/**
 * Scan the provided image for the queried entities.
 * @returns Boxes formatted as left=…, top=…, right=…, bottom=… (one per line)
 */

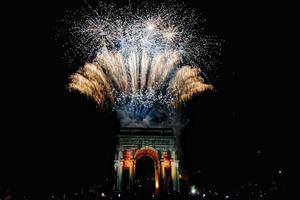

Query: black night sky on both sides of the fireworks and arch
left=0, top=0, right=300, bottom=199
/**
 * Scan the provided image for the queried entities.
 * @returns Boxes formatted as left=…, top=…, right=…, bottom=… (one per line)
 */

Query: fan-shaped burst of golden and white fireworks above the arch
left=64, top=0, right=218, bottom=127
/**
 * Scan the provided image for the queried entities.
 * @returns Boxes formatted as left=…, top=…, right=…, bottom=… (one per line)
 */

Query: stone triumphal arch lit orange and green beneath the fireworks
left=113, top=128, right=180, bottom=194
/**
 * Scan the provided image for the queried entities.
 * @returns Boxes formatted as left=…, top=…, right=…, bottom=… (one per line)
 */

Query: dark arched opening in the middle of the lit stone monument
left=135, top=155, right=155, bottom=196
